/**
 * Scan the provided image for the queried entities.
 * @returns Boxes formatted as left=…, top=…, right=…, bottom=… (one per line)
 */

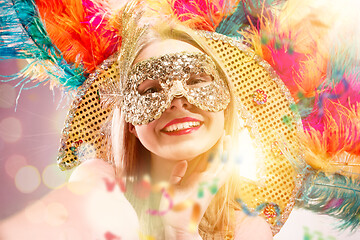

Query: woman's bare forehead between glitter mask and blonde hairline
left=134, top=39, right=202, bottom=64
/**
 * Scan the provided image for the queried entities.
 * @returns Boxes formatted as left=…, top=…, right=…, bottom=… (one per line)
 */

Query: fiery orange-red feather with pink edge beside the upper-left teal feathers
left=36, top=0, right=121, bottom=73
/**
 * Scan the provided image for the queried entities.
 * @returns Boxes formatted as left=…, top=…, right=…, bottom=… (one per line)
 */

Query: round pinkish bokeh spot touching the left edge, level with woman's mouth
left=0, top=117, right=22, bottom=143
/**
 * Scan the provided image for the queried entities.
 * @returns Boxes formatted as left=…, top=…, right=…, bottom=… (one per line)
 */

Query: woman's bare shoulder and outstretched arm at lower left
left=0, top=159, right=139, bottom=240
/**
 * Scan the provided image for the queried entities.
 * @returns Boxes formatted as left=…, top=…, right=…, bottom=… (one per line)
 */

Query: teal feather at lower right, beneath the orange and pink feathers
left=296, top=171, right=360, bottom=230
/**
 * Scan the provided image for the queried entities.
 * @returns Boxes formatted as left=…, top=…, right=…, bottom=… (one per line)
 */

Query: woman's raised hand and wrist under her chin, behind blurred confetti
left=160, top=151, right=229, bottom=240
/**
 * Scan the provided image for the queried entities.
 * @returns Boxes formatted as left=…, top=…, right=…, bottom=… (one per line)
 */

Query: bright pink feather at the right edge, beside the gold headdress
left=303, top=74, right=360, bottom=155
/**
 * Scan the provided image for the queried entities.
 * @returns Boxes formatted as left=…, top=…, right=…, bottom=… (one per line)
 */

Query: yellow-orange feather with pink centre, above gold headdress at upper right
left=241, top=1, right=334, bottom=103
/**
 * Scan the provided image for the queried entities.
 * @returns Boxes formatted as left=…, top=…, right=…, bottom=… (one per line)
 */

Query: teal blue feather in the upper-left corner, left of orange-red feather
left=0, top=0, right=86, bottom=89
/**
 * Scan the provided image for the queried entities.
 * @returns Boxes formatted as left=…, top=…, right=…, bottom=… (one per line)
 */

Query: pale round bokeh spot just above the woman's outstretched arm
left=42, top=164, right=67, bottom=189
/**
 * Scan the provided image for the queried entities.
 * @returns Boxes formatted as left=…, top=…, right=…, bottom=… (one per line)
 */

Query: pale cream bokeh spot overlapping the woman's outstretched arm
left=45, top=202, right=69, bottom=227
